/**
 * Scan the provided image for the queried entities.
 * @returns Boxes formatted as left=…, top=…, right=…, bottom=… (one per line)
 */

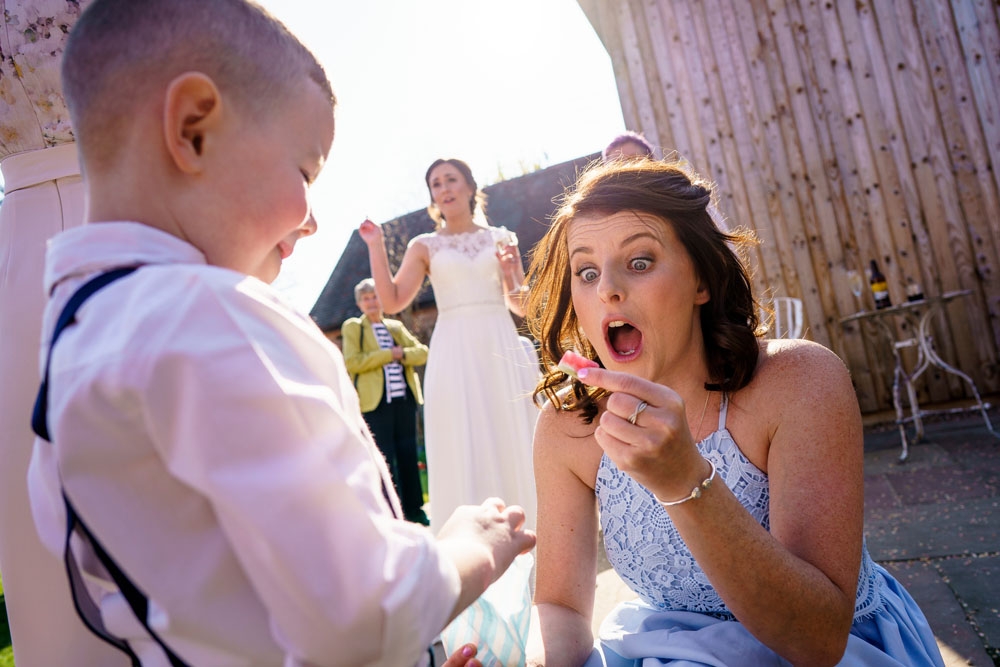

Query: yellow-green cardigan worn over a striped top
left=340, top=315, right=427, bottom=412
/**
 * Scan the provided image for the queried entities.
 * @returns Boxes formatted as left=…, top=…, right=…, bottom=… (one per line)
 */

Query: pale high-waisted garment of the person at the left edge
left=0, top=144, right=128, bottom=667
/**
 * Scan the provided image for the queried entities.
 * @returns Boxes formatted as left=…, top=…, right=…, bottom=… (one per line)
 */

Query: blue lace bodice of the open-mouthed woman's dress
left=595, top=400, right=882, bottom=620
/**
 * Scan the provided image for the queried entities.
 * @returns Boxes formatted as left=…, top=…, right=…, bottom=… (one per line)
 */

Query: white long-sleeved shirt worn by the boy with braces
left=29, top=223, right=460, bottom=666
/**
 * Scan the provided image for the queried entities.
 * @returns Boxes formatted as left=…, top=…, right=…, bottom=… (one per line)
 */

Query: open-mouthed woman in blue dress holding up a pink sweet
left=528, top=160, right=943, bottom=667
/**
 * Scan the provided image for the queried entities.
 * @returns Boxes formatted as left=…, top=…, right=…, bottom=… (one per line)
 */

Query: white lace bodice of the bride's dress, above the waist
left=410, top=227, right=510, bottom=314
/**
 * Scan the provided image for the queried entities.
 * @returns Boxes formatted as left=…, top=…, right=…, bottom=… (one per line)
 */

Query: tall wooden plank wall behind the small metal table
left=578, top=0, right=1000, bottom=412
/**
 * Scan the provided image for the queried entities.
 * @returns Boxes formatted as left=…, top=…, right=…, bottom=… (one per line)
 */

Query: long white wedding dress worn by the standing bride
left=411, top=227, right=539, bottom=532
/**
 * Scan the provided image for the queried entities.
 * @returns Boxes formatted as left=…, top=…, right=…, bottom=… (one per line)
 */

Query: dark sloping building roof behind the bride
left=309, top=153, right=600, bottom=332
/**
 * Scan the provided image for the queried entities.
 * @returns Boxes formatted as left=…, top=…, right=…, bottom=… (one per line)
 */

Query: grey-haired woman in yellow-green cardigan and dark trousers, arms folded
left=340, top=278, right=428, bottom=526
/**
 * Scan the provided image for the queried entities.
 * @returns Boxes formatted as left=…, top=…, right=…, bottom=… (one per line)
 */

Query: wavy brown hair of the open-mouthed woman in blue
left=526, top=160, right=763, bottom=422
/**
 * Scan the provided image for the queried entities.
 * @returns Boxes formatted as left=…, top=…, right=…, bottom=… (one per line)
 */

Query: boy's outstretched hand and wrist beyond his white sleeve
left=438, top=498, right=535, bottom=621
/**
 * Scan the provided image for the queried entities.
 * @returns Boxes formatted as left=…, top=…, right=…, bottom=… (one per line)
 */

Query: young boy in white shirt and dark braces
left=29, top=0, right=534, bottom=665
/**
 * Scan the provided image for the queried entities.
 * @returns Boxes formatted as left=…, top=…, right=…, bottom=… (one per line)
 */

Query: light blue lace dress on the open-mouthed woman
left=586, top=399, right=944, bottom=667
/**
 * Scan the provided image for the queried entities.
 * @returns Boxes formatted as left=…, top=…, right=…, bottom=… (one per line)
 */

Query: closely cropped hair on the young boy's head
left=62, top=0, right=335, bottom=170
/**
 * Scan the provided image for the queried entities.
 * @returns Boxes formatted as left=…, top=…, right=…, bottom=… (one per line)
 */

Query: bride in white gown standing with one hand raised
left=358, top=158, right=539, bottom=532
